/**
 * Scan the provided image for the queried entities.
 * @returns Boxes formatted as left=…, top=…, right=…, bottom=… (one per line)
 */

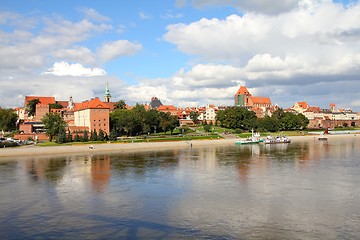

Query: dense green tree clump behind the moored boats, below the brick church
left=216, top=107, right=309, bottom=132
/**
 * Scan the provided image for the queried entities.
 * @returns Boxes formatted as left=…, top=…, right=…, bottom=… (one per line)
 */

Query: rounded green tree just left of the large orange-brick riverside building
left=41, top=112, right=66, bottom=141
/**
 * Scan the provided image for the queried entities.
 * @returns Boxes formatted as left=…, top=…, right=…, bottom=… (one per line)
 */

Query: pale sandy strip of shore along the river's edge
left=0, top=134, right=357, bottom=161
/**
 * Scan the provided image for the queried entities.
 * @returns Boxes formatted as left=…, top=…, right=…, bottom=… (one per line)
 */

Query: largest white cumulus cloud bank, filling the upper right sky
left=164, top=1, right=360, bottom=80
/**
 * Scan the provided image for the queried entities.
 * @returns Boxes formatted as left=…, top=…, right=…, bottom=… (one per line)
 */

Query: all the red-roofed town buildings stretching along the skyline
left=12, top=84, right=360, bottom=140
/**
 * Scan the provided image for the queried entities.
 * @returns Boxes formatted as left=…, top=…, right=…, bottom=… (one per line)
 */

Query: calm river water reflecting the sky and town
left=0, top=136, right=360, bottom=239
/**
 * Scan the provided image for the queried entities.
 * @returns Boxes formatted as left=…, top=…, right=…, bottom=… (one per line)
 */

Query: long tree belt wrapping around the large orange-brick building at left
left=42, top=104, right=179, bottom=143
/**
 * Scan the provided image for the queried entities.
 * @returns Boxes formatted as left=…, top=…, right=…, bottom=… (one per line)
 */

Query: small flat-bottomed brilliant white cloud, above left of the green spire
left=43, top=62, right=106, bottom=77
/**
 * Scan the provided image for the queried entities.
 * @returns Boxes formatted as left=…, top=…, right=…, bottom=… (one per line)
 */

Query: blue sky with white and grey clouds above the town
left=0, top=0, right=360, bottom=111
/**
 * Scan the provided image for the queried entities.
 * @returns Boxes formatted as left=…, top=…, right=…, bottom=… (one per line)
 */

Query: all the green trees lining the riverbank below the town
left=0, top=99, right=309, bottom=143
